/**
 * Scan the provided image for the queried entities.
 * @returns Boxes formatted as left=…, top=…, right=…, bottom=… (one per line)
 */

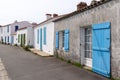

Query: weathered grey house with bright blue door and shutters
left=54, top=0, right=120, bottom=78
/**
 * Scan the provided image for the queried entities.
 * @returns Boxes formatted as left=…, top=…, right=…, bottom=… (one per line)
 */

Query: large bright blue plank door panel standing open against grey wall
left=92, top=22, right=110, bottom=77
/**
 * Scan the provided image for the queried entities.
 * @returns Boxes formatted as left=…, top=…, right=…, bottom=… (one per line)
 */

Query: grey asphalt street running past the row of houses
left=0, top=44, right=108, bottom=80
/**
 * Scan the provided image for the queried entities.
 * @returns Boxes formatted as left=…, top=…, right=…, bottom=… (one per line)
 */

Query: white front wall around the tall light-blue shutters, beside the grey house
left=34, top=22, right=54, bottom=55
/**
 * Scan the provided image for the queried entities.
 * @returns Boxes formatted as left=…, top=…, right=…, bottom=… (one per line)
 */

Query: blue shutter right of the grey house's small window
left=64, top=30, right=69, bottom=52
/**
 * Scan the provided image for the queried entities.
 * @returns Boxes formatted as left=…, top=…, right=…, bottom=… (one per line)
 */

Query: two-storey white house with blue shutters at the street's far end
left=0, top=21, right=32, bottom=45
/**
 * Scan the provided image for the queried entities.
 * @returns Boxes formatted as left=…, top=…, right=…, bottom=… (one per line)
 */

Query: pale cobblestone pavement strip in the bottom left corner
left=0, top=58, right=10, bottom=80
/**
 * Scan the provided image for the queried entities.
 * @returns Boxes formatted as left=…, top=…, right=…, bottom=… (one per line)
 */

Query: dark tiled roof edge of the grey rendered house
left=54, top=0, right=113, bottom=22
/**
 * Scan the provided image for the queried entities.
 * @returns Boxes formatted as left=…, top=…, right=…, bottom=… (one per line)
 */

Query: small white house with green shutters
left=17, top=27, right=34, bottom=46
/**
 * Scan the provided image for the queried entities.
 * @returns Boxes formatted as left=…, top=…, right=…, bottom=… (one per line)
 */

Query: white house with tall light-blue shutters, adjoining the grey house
left=34, top=14, right=61, bottom=55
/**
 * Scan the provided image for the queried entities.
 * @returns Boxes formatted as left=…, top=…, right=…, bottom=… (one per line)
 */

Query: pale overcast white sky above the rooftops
left=0, top=0, right=97, bottom=25
